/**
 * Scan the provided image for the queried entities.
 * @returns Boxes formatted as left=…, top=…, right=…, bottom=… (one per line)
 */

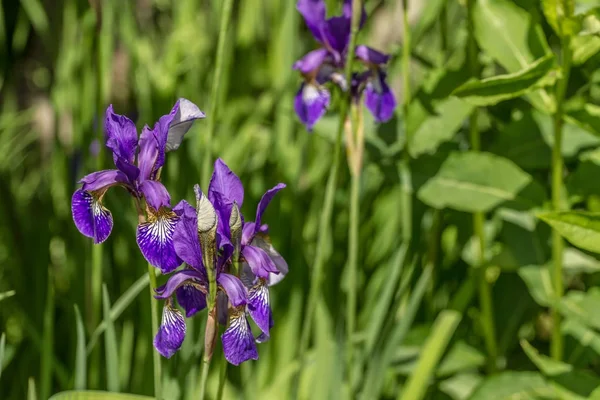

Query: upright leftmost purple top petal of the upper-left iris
left=104, top=104, right=138, bottom=165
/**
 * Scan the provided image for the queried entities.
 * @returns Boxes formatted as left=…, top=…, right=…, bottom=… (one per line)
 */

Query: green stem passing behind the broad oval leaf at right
left=467, top=0, right=498, bottom=373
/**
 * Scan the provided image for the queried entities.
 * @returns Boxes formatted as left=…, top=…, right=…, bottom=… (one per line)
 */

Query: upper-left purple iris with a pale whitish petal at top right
left=71, top=98, right=204, bottom=273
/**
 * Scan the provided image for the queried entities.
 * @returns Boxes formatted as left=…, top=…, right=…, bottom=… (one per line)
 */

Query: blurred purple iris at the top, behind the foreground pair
left=293, top=0, right=396, bottom=131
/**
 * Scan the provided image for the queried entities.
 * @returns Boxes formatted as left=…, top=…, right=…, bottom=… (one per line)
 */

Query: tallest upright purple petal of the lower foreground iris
left=208, top=158, right=244, bottom=238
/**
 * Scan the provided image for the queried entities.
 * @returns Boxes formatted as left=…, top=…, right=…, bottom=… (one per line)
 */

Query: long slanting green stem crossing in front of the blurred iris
left=293, top=0, right=362, bottom=397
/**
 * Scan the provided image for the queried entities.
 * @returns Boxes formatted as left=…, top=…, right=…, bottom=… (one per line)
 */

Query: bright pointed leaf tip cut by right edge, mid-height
left=538, top=211, right=600, bottom=253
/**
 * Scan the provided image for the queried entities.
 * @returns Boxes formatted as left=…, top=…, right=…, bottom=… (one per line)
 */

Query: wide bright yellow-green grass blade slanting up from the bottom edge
left=398, top=310, right=462, bottom=400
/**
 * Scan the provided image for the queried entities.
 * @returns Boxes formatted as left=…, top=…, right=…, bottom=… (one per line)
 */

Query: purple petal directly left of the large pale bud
left=173, top=200, right=204, bottom=271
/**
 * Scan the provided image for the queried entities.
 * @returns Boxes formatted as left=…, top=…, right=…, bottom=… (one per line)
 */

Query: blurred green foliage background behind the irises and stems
left=0, top=0, right=600, bottom=400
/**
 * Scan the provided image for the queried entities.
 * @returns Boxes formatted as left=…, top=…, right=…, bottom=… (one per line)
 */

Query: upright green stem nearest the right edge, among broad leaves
left=550, top=1, right=573, bottom=361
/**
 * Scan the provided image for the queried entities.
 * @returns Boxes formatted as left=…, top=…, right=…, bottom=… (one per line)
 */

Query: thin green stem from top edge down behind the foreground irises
left=200, top=0, right=233, bottom=187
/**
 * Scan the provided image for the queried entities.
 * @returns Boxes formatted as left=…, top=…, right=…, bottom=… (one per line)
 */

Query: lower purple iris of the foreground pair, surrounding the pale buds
left=154, top=159, right=288, bottom=365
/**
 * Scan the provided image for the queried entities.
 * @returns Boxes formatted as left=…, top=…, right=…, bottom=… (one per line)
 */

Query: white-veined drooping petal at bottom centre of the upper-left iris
left=137, top=207, right=181, bottom=273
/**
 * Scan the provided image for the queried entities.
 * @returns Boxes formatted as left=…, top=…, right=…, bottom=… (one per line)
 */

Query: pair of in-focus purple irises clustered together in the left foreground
left=71, top=99, right=288, bottom=365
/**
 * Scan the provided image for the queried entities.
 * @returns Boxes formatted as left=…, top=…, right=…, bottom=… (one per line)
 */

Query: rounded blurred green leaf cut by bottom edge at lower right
left=469, top=371, right=557, bottom=400
